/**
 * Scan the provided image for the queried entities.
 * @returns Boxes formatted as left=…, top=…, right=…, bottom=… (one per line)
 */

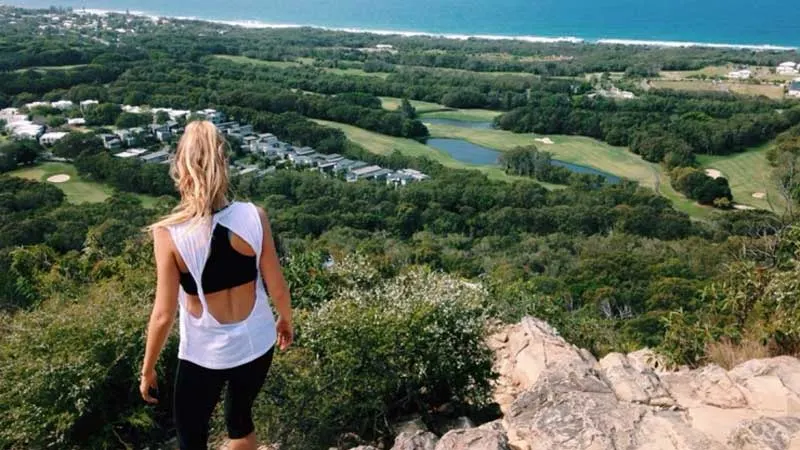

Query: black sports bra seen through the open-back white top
left=181, top=224, right=258, bottom=295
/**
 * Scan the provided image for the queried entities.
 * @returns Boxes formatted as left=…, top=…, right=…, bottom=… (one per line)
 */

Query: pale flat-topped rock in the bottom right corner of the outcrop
left=728, top=417, right=800, bottom=450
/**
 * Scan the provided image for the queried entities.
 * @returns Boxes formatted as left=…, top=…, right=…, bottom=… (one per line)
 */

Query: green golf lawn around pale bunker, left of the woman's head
left=9, top=162, right=156, bottom=208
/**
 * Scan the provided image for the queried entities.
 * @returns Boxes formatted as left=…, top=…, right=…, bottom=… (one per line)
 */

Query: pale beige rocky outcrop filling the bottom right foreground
left=488, top=318, right=800, bottom=450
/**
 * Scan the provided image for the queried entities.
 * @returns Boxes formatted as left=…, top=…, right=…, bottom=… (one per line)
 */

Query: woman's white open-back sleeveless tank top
left=169, top=202, right=277, bottom=369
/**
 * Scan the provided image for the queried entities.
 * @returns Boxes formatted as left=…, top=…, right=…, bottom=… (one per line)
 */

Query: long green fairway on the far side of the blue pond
left=428, top=125, right=661, bottom=189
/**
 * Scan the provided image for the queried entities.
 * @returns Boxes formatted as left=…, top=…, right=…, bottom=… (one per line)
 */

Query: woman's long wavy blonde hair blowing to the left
left=148, top=120, right=228, bottom=231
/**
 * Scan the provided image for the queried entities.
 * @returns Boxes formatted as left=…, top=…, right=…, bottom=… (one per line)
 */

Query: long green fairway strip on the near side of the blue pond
left=313, top=119, right=552, bottom=185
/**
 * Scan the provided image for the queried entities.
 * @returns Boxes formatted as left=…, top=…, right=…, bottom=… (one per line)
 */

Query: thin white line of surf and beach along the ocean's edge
left=73, top=8, right=800, bottom=51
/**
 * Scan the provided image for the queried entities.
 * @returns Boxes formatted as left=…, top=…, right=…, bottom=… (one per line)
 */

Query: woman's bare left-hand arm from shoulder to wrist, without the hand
left=142, top=228, right=180, bottom=384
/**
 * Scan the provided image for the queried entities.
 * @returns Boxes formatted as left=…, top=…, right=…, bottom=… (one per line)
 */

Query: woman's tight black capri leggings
left=174, top=348, right=274, bottom=450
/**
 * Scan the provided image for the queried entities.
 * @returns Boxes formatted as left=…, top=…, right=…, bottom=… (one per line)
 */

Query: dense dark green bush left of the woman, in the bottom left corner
left=0, top=272, right=176, bottom=448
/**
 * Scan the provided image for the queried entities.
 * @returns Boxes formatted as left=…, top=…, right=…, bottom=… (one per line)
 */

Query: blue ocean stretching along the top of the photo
left=10, top=0, right=800, bottom=47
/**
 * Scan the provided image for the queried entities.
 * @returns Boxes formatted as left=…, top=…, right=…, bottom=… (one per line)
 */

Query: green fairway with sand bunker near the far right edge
left=697, top=144, right=786, bottom=213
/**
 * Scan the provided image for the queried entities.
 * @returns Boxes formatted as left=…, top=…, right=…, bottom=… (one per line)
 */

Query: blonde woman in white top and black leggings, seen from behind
left=140, top=121, right=293, bottom=450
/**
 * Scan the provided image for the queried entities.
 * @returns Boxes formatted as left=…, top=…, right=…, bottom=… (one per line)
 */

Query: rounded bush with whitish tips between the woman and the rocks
left=256, top=269, right=493, bottom=448
